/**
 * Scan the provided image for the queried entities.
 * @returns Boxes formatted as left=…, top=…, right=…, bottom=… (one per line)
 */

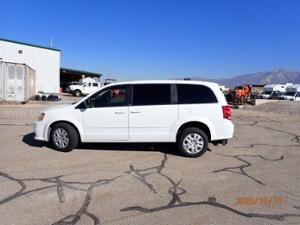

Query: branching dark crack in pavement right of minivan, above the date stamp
left=213, top=154, right=284, bottom=185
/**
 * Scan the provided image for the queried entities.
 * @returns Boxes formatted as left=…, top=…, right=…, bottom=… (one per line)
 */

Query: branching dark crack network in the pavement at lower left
left=0, top=172, right=121, bottom=225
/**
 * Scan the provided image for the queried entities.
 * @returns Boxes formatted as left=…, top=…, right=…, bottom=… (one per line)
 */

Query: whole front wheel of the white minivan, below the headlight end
left=50, top=123, right=79, bottom=152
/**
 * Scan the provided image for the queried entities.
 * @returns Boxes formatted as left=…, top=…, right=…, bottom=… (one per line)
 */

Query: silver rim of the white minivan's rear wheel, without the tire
left=183, top=133, right=204, bottom=154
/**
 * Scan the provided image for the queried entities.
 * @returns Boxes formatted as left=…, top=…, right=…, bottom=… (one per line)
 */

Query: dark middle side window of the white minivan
left=132, top=84, right=171, bottom=106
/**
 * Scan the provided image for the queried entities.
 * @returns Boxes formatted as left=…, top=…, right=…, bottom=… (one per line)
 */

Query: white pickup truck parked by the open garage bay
left=69, top=78, right=101, bottom=97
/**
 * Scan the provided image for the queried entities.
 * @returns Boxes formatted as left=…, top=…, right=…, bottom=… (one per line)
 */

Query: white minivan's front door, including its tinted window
left=82, top=85, right=128, bottom=142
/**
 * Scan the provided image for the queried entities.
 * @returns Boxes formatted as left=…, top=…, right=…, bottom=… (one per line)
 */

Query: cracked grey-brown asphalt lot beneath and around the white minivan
left=0, top=102, right=300, bottom=225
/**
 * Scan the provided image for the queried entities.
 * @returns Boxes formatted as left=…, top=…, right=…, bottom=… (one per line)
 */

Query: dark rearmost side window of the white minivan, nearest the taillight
left=177, top=84, right=218, bottom=104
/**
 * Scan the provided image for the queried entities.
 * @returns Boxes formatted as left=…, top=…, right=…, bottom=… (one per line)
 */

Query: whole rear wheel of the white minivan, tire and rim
left=177, top=127, right=208, bottom=157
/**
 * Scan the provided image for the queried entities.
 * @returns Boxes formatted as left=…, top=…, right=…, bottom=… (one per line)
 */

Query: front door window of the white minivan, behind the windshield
left=91, top=86, right=128, bottom=107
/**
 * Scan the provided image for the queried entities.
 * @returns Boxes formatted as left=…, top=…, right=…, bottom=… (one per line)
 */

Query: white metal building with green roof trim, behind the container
left=0, top=39, right=60, bottom=92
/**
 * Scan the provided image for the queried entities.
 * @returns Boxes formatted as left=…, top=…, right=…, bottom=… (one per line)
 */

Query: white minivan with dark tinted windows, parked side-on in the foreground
left=35, top=80, right=234, bottom=157
